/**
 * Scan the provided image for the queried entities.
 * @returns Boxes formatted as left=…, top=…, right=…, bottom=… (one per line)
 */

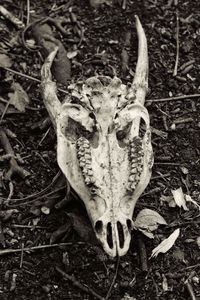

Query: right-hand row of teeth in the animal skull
left=128, top=137, right=144, bottom=192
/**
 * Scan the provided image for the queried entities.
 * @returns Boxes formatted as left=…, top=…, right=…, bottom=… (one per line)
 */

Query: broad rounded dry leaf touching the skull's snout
left=134, top=208, right=167, bottom=238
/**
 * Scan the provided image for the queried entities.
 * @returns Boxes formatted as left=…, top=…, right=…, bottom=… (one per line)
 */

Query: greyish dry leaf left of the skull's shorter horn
left=8, top=82, right=29, bottom=112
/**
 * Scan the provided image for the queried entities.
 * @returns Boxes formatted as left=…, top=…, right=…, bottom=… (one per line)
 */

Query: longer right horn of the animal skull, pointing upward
left=132, top=16, right=148, bottom=105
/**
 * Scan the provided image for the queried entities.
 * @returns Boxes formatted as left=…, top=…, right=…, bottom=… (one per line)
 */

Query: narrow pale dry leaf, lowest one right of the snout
left=151, top=228, right=180, bottom=257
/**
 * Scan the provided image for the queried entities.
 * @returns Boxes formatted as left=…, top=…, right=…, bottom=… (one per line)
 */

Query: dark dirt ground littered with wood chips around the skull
left=0, top=0, right=200, bottom=300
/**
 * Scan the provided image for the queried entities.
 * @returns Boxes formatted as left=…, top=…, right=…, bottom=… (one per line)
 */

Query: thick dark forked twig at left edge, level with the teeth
left=0, top=128, right=30, bottom=181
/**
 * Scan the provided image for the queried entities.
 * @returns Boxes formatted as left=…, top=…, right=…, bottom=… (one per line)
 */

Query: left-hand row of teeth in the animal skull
left=76, top=137, right=95, bottom=186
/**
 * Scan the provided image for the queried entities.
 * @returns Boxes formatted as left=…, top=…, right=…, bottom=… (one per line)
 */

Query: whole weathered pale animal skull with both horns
left=41, top=16, right=153, bottom=257
